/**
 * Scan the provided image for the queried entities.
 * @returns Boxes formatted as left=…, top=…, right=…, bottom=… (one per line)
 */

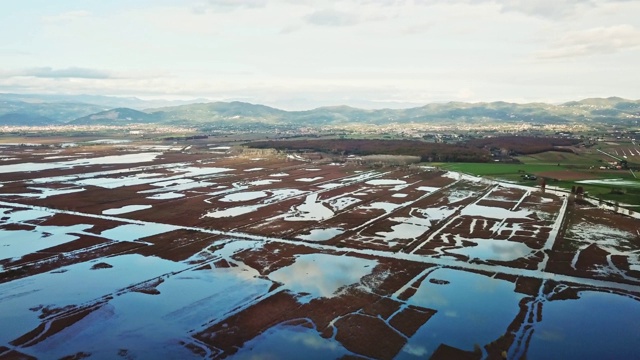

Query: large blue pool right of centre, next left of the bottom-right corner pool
left=396, top=269, right=533, bottom=359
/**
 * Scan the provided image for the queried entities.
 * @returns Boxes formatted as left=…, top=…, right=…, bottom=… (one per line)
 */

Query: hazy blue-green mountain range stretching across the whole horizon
left=0, top=94, right=640, bottom=127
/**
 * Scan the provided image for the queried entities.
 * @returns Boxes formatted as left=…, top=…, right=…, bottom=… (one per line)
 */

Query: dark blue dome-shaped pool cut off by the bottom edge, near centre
left=233, top=325, right=352, bottom=360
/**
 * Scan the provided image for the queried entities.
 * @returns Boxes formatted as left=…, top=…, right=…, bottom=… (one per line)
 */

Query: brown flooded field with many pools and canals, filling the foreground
left=0, top=140, right=640, bottom=359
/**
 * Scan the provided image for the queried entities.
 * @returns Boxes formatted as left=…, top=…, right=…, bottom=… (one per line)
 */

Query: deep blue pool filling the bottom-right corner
left=526, top=291, right=640, bottom=359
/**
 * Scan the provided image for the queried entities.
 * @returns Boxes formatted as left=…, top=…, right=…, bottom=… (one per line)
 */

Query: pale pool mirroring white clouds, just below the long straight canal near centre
left=269, top=254, right=377, bottom=303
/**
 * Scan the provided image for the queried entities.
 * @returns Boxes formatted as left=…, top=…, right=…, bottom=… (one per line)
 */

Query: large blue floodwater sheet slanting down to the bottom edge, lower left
left=26, top=260, right=272, bottom=359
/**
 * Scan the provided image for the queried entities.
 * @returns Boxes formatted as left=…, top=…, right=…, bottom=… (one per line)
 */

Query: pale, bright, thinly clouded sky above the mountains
left=0, top=0, right=640, bottom=110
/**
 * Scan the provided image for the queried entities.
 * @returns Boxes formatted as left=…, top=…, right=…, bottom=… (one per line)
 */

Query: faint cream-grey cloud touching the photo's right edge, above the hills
left=538, top=24, right=640, bottom=59
